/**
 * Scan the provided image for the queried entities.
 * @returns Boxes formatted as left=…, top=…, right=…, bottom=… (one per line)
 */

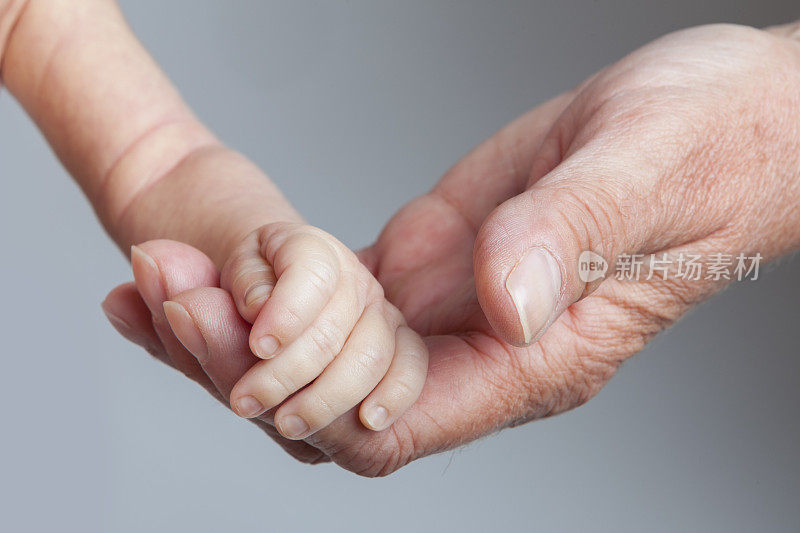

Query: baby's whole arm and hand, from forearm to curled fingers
left=0, top=0, right=428, bottom=439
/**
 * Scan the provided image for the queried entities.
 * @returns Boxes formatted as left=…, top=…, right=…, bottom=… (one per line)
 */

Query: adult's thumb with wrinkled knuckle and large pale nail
left=474, top=147, right=700, bottom=346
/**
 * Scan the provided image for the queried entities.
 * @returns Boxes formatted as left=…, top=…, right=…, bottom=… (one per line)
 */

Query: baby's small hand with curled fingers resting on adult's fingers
left=222, top=222, right=428, bottom=439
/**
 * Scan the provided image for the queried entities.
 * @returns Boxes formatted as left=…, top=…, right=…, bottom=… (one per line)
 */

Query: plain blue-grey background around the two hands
left=0, top=0, right=800, bottom=532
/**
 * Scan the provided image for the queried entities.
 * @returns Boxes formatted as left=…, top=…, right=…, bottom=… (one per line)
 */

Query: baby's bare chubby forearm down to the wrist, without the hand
left=0, top=0, right=297, bottom=261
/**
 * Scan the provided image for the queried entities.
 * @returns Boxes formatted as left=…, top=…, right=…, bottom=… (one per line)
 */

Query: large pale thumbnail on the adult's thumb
left=506, top=247, right=561, bottom=344
